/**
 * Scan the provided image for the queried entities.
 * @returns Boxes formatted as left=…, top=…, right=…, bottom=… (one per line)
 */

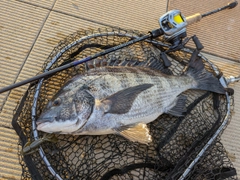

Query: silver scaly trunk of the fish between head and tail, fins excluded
left=71, top=67, right=191, bottom=134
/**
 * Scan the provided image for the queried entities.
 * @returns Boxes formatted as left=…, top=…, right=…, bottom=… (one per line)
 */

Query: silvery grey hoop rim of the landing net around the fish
left=31, top=30, right=231, bottom=180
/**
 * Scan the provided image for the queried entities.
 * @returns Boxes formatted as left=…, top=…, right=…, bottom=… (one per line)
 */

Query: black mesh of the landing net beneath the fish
left=13, top=28, right=237, bottom=180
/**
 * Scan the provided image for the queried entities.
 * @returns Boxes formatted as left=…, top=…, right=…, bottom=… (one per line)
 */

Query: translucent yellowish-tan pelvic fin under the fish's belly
left=115, top=123, right=152, bottom=144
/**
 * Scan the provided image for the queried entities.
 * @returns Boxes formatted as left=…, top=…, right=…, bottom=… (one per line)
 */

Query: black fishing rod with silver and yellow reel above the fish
left=0, top=1, right=238, bottom=93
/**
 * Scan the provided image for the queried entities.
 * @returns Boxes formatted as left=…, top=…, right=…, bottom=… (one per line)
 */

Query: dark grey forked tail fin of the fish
left=186, top=58, right=226, bottom=94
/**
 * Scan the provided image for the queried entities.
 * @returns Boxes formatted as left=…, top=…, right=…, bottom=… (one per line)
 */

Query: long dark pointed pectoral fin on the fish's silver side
left=101, top=84, right=153, bottom=114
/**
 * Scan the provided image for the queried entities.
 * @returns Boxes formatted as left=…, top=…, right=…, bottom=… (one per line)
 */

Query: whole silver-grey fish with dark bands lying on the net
left=36, top=58, right=226, bottom=144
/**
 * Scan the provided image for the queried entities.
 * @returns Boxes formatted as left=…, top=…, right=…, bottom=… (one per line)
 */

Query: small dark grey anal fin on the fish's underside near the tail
left=166, top=95, right=187, bottom=117
